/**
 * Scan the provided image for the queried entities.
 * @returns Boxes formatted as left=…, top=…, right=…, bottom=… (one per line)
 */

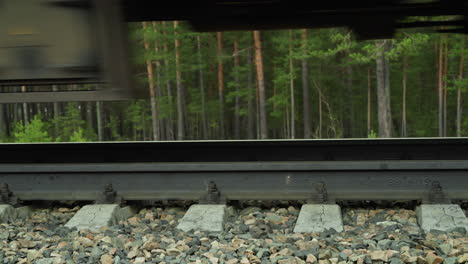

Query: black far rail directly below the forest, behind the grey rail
left=0, top=138, right=468, bottom=164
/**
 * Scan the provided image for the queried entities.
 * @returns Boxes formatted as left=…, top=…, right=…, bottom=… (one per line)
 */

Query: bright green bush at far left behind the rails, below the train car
left=14, top=115, right=52, bottom=143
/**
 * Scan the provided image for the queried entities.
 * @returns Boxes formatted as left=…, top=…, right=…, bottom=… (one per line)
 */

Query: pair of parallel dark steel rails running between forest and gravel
left=0, top=138, right=468, bottom=203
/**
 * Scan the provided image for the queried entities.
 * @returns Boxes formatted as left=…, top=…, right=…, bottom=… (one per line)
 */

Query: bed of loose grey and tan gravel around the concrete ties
left=0, top=203, right=468, bottom=264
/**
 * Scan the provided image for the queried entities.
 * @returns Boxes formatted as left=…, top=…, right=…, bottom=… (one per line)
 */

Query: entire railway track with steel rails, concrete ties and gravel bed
left=0, top=139, right=468, bottom=264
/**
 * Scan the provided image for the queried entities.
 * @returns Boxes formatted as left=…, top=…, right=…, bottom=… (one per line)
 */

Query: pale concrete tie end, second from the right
left=294, top=204, right=343, bottom=233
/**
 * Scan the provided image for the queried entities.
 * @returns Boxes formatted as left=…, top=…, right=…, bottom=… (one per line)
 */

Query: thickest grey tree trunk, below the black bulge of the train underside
left=376, top=40, right=392, bottom=138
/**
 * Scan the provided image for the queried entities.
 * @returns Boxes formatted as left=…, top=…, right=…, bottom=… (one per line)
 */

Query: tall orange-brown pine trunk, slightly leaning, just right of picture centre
left=253, top=30, right=268, bottom=139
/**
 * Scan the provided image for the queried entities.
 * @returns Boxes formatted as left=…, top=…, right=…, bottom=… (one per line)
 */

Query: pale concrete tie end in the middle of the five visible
left=177, top=204, right=226, bottom=232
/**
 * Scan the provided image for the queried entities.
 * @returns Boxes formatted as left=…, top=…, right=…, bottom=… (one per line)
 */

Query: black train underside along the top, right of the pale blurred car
left=123, top=0, right=468, bottom=39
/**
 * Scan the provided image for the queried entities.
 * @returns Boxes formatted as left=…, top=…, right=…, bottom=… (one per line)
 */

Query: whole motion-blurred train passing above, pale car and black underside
left=0, top=0, right=468, bottom=103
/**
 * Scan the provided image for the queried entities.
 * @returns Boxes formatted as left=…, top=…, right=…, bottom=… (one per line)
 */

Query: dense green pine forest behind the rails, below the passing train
left=0, top=21, right=468, bottom=142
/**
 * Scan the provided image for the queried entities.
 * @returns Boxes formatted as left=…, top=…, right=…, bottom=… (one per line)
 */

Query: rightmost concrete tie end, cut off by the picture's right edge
left=416, top=204, right=468, bottom=232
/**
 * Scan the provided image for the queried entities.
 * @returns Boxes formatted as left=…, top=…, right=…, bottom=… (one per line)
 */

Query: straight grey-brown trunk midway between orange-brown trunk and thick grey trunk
left=301, top=29, right=312, bottom=138
